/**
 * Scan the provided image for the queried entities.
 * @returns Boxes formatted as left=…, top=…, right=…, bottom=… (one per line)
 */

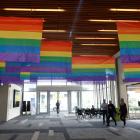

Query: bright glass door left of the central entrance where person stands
left=39, top=92, right=47, bottom=113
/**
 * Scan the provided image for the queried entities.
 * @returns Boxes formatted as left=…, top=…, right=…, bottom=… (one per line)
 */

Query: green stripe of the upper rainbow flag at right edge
left=120, top=41, right=140, bottom=48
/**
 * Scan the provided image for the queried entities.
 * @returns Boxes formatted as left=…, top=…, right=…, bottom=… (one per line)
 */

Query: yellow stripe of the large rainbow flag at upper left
left=0, top=31, right=42, bottom=39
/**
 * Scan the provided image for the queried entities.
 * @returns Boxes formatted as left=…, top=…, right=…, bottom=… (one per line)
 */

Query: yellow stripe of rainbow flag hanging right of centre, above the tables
left=72, top=64, right=115, bottom=69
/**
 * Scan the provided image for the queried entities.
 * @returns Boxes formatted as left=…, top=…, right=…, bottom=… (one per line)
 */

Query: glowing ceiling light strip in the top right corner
left=109, top=8, right=140, bottom=12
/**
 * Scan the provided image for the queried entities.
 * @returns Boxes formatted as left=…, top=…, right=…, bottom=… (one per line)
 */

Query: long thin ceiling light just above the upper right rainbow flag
left=88, top=19, right=140, bottom=22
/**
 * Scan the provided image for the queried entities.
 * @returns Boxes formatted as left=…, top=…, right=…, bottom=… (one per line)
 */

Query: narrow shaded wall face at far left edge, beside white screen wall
left=0, top=85, right=8, bottom=121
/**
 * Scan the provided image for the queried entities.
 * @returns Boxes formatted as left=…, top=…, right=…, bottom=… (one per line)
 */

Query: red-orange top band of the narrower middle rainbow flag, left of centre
left=41, top=40, right=72, bottom=52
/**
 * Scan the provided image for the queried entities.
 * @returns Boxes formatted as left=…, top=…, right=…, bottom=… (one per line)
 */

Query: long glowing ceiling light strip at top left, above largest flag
left=3, top=8, right=66, bottom=12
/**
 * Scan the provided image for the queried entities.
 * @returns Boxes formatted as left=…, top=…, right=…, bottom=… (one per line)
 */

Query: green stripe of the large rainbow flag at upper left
left=0, top=38, right=41, bottom=47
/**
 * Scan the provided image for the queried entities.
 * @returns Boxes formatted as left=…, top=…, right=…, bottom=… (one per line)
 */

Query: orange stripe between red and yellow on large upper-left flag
left=0, top=23, right=42, bottom=32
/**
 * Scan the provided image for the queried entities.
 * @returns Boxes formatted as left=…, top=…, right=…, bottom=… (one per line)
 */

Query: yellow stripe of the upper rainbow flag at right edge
left=118, top=34, right=140, bottom=41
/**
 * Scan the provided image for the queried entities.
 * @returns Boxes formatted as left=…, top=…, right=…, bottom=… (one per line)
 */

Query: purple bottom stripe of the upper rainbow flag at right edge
left=121, top=55, right=140, bottom=63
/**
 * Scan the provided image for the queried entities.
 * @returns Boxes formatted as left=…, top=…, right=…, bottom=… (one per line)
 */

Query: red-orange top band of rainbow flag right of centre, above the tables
left=72, top=56, right=114, bottom=64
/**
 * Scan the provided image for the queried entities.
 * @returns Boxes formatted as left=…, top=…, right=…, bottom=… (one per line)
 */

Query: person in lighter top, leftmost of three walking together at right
left=101, top=99, right=108, bottom=125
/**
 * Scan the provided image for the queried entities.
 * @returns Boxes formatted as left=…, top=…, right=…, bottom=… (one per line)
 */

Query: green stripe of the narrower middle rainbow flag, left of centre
left=40, top=56, right=71, bottom=62
